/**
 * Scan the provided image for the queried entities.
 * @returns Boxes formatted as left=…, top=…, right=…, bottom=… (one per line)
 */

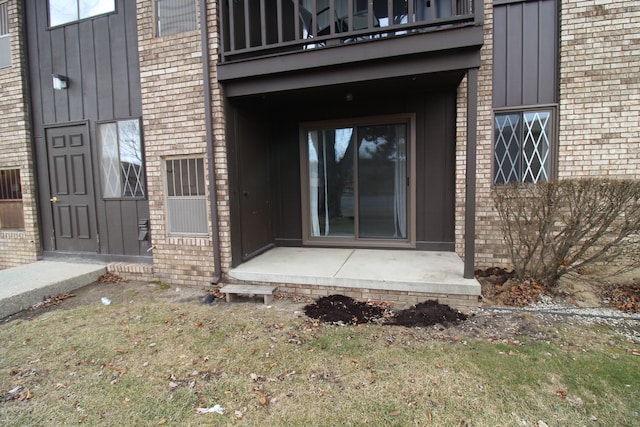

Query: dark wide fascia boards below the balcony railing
left=217, top=26, right=483, bottom=97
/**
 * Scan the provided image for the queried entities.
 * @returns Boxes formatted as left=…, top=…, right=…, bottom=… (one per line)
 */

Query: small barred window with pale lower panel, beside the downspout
left=165, top=158, right=208, bottom=234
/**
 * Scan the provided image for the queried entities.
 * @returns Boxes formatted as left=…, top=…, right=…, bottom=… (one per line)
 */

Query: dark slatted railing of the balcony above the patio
left=220, top=0, right=474, bottom=62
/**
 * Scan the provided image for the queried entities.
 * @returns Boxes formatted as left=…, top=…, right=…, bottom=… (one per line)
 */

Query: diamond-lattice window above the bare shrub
left=493, top=109, right=553, bottom=185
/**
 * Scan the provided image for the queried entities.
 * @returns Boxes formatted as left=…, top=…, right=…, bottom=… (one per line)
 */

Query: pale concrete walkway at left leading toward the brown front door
left=0, top=261, right=107, bottom=319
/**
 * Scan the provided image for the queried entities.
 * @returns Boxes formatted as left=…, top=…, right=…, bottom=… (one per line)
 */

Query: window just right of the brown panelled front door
left=98, top=120, right=145, bottom=199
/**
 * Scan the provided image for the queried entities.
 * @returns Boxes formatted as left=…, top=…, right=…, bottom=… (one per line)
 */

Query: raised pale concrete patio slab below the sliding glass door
left=229, top=247, right=480, bottom=296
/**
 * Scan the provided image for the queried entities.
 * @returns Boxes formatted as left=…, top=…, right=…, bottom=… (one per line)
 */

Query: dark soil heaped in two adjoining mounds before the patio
left=304, top=295, right=467, bottom=326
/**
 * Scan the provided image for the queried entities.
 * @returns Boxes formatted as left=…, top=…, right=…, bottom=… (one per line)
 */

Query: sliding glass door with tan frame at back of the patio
left=301, top=116, right=414, bottom=246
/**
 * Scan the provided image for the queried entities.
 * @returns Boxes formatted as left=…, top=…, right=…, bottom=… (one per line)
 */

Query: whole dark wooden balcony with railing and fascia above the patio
left=217, top=0, right=483, bottom=96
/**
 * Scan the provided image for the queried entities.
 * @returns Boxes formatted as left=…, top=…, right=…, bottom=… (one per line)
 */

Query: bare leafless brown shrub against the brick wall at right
left=494, top=179, right=640, bottom=289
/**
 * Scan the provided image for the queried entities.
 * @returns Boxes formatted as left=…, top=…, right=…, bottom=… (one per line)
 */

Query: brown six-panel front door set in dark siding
left=47, top=125, right=98, bottom=252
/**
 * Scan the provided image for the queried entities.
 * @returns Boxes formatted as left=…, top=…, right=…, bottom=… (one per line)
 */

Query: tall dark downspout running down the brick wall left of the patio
left=200, top=0, right=222, bottom=286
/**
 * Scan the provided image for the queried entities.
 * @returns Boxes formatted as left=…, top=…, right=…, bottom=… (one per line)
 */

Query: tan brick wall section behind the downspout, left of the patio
left=137, top=0, right=231, bottom=286
